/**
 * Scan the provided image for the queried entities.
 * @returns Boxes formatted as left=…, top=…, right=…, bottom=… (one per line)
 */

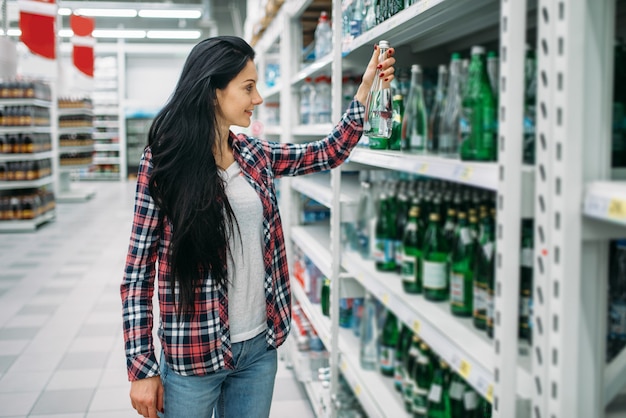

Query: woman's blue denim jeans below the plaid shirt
left=159, top=332, right=277, bottom=418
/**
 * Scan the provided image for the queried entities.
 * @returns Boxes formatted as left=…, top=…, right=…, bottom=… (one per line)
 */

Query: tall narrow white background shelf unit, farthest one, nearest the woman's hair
left=85, top=55, right=125, bottom=181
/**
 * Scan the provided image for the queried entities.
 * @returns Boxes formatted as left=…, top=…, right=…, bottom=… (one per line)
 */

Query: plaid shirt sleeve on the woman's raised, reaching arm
left=265, top=100, right=365, bottom=177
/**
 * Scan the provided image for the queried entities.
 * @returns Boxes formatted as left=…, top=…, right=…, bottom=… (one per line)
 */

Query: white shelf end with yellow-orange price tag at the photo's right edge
left=583, top=181, right=626, bottom=226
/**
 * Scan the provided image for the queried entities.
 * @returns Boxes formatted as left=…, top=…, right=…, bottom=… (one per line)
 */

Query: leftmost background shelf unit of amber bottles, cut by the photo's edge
left=0, top=80, right=56, bottom=232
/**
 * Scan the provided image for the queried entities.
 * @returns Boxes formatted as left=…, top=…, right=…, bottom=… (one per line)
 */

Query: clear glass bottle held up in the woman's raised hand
left=363, top=41, right=393, bottom=144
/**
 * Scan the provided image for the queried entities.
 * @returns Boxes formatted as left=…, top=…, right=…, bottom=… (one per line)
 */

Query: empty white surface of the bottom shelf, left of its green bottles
left=339, top=328, right=411, bottom=418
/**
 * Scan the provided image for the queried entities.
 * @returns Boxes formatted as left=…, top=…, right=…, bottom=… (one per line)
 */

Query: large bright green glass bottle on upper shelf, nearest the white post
left=459, top=46, right=497, bottom=161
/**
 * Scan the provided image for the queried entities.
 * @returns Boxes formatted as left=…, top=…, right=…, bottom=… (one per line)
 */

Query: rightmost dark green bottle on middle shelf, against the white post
left=473, top=214, right=495, bottom=330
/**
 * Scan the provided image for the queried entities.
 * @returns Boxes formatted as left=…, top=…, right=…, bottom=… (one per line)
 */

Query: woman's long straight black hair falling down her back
left=148, top=36, right=254, bottom=315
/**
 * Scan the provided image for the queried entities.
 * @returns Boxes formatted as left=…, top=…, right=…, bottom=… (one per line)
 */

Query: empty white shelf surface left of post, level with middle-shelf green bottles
left=291, top=222, right=332, bottom=277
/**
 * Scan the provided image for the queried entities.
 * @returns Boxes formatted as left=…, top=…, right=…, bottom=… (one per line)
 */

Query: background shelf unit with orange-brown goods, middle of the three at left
left=57, top=97, right=95, bottom=203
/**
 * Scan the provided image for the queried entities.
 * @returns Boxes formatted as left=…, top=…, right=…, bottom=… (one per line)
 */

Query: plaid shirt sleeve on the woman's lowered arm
left=120, top=149, right=159, bottom=381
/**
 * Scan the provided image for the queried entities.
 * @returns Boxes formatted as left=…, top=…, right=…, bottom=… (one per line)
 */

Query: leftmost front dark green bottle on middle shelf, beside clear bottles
left=372, top=192, right=396, bottom=271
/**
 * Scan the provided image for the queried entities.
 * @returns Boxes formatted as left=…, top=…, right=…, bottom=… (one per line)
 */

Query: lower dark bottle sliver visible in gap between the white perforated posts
left=519, top=219, right=534, bottom=342
